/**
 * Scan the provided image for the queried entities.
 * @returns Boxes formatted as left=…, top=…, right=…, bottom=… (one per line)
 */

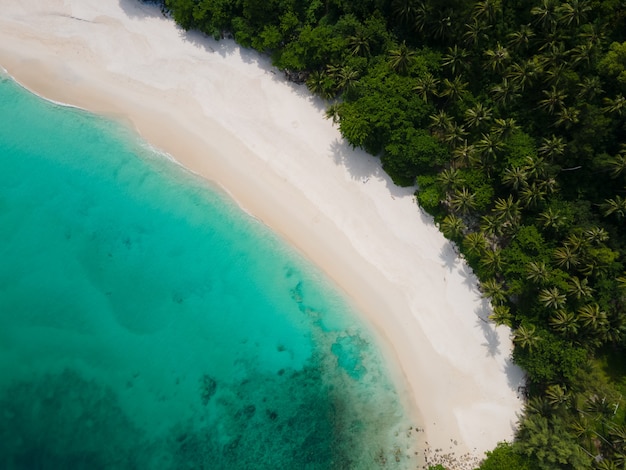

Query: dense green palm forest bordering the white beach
left=149, top=0, right=626, bottom=470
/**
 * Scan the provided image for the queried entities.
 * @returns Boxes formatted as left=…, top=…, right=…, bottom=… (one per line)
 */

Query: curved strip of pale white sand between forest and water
left=0, top=0, right=522, bottom=467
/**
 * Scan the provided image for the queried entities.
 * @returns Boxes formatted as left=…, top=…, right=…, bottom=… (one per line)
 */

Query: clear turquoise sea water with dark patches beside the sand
left=0, top=77, right=410, bottom=469
